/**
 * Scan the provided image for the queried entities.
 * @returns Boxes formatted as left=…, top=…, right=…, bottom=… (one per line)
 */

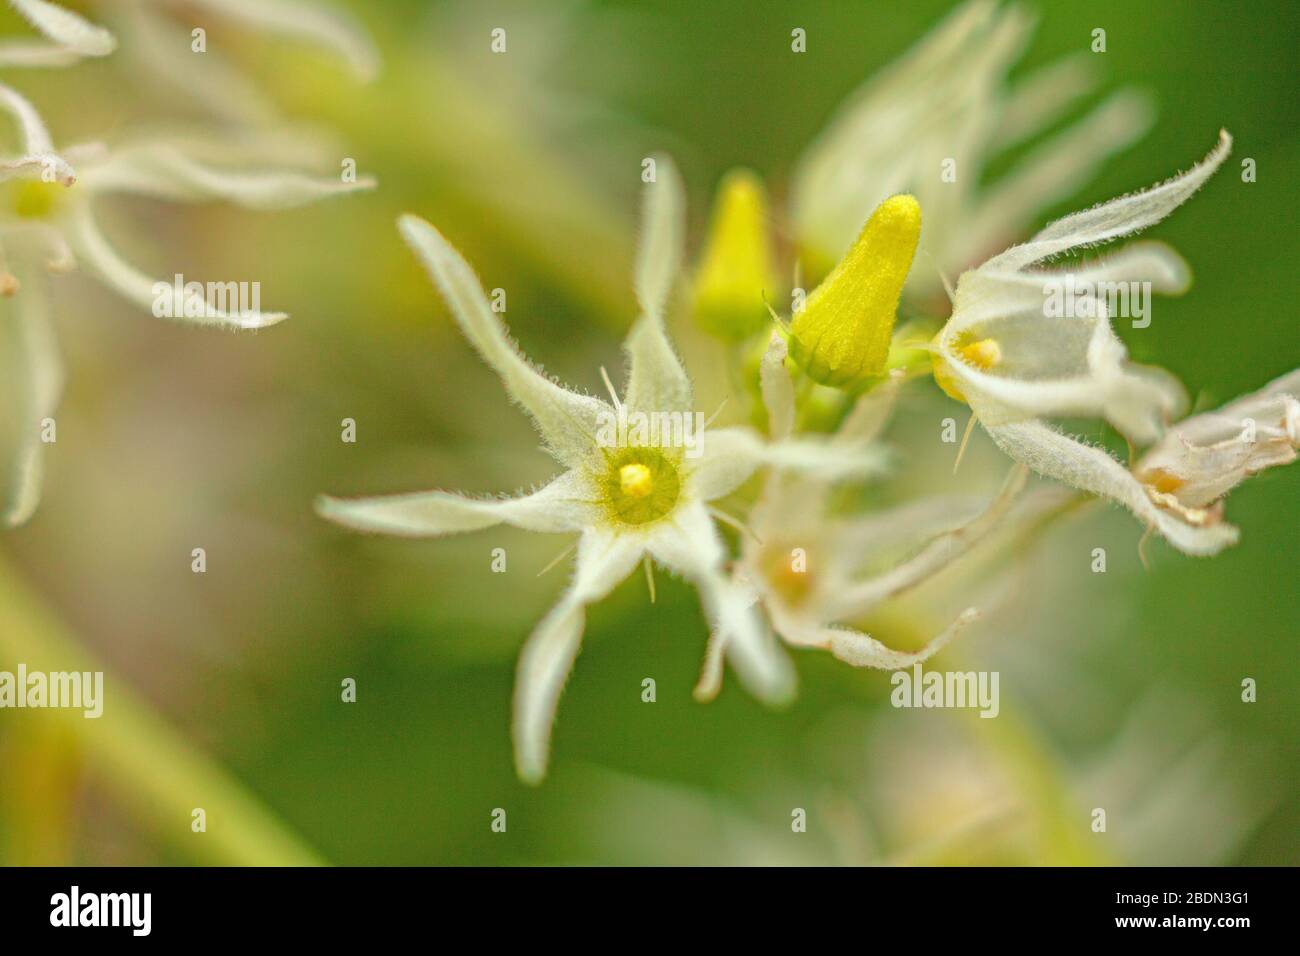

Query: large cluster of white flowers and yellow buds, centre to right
left=319, top=0, right=1300, bottom=782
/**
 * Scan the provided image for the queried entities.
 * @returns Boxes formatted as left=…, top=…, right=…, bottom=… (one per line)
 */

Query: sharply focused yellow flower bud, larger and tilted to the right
left=790, top=195, right=920, bottom=388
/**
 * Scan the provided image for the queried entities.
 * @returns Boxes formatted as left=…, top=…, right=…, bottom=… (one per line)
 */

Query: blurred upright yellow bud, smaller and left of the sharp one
left=692, top=169, right=776, bottom=341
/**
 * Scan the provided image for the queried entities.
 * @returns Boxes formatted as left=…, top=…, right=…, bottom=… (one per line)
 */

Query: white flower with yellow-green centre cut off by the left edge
left=0, top=98, right=374, bottom=527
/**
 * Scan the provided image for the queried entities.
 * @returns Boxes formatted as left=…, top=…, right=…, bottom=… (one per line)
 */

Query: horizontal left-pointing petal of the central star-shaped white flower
left=316, top=471, right=595, bottom=537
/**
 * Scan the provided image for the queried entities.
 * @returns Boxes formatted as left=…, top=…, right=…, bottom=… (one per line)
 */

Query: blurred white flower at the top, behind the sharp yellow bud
left=790, top=0, right=1152, bottom=298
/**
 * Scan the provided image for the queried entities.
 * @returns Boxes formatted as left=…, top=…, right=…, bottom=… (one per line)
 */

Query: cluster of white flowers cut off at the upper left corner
left=0, top=0, right=376, bottom=527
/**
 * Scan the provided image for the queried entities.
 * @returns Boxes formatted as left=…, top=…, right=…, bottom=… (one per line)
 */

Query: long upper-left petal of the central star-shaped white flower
left=398, top=215, right=614, bottom=467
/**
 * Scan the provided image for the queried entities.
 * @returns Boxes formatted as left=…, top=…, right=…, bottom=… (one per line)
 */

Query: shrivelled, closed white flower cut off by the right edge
left=1134, top=369, right=1300, bottom=522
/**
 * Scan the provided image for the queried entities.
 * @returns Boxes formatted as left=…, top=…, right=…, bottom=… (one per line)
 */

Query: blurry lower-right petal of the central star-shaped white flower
left=646, top=503, right=794, bottom=704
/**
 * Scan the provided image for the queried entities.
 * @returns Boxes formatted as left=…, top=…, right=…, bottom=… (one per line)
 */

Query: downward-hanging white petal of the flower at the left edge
left=0, top=282, right=64, bottom=528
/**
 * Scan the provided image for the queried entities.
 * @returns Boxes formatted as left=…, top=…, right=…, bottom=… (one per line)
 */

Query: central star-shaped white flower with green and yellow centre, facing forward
left=319, top=157, right=879, bottom=783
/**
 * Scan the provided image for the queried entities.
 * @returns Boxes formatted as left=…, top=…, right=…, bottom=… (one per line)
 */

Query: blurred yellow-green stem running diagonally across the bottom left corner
left=0, top=546, right=324, bottom=866
